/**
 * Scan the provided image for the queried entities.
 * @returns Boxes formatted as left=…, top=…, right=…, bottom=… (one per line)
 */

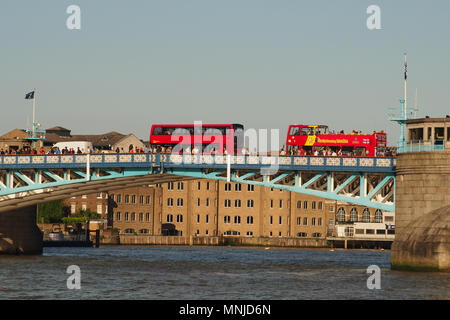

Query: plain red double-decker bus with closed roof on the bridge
left=150, top=124, right=244, bottom=154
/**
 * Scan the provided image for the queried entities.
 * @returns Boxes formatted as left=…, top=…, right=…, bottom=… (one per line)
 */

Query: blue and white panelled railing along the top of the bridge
left=0, top=153, right=395, bottom=171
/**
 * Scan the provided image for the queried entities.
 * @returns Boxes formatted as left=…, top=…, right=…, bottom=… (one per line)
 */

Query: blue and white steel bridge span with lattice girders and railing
left=0, top=153, right=395, bottom=212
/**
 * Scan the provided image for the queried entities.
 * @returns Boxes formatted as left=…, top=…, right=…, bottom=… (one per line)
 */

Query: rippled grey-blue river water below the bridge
left=0, top=246, right=450, bottom=300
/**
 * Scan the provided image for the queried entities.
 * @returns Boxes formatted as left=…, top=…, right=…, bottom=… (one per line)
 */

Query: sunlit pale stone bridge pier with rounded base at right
left=391, top=150, right=450, bottom=271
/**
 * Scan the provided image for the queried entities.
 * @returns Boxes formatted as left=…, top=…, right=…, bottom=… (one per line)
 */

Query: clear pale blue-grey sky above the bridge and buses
left=0, top=0, right=450, bottom=145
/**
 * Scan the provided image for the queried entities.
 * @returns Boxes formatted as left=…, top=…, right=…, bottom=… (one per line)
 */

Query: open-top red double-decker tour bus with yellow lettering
left=286, top=125, right=386, bottom=157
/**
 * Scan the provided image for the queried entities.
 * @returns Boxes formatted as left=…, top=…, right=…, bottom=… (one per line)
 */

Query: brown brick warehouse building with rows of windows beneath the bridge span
left=66, top=180, right=394, bottom=245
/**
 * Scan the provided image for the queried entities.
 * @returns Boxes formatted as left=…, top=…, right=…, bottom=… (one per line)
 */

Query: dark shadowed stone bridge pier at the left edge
left=0, top=206, right=43, bottom=254
